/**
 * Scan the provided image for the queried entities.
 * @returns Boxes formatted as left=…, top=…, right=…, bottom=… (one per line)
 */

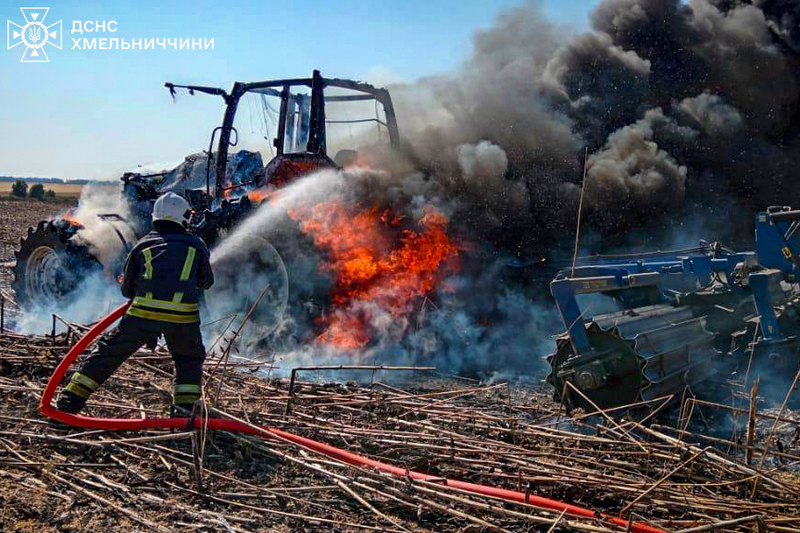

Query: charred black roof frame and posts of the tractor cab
left=164, top=70, right=400, bottom=196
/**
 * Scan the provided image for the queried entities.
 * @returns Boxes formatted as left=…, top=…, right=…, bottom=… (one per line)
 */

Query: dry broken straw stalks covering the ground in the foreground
left=0, top=314, right=800, bottom=532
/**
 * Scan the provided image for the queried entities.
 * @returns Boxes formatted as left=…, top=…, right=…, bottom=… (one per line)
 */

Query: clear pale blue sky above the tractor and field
left=0, top=0, right=599, bottom=179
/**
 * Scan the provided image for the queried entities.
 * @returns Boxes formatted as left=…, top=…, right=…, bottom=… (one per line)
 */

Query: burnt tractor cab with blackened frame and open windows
left=165, top=70, right=399, bottom=201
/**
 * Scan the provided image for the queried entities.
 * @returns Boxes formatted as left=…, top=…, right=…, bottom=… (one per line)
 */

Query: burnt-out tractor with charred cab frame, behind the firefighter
left=13, top=70, right=400, bottom=320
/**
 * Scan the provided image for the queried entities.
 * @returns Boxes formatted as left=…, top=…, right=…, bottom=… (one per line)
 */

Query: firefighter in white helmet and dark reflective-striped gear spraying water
left=57, top=192, right=214, bottom=413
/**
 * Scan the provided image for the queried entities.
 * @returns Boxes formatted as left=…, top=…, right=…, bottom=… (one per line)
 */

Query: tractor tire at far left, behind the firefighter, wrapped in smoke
left=11, top=219, right=102, bottom=309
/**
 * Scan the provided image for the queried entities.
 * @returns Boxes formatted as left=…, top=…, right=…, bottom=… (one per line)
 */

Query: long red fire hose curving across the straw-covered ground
left=39, top=303, right=664, bottom=533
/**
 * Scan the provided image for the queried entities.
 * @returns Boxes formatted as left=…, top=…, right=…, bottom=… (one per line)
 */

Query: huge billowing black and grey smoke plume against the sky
left=384, top=0, right=800, bottom=254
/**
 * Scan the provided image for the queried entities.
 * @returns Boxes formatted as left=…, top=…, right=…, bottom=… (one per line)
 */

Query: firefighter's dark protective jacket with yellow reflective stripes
left=122, top=223, right=214, bottom=324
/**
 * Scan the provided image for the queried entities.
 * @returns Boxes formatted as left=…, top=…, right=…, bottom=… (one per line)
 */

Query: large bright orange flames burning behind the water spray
left=290, top=201, right=459, bottom=349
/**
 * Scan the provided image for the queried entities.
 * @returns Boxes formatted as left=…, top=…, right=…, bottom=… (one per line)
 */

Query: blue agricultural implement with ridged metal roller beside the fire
left=547, top=207, right=800, bottom=408
